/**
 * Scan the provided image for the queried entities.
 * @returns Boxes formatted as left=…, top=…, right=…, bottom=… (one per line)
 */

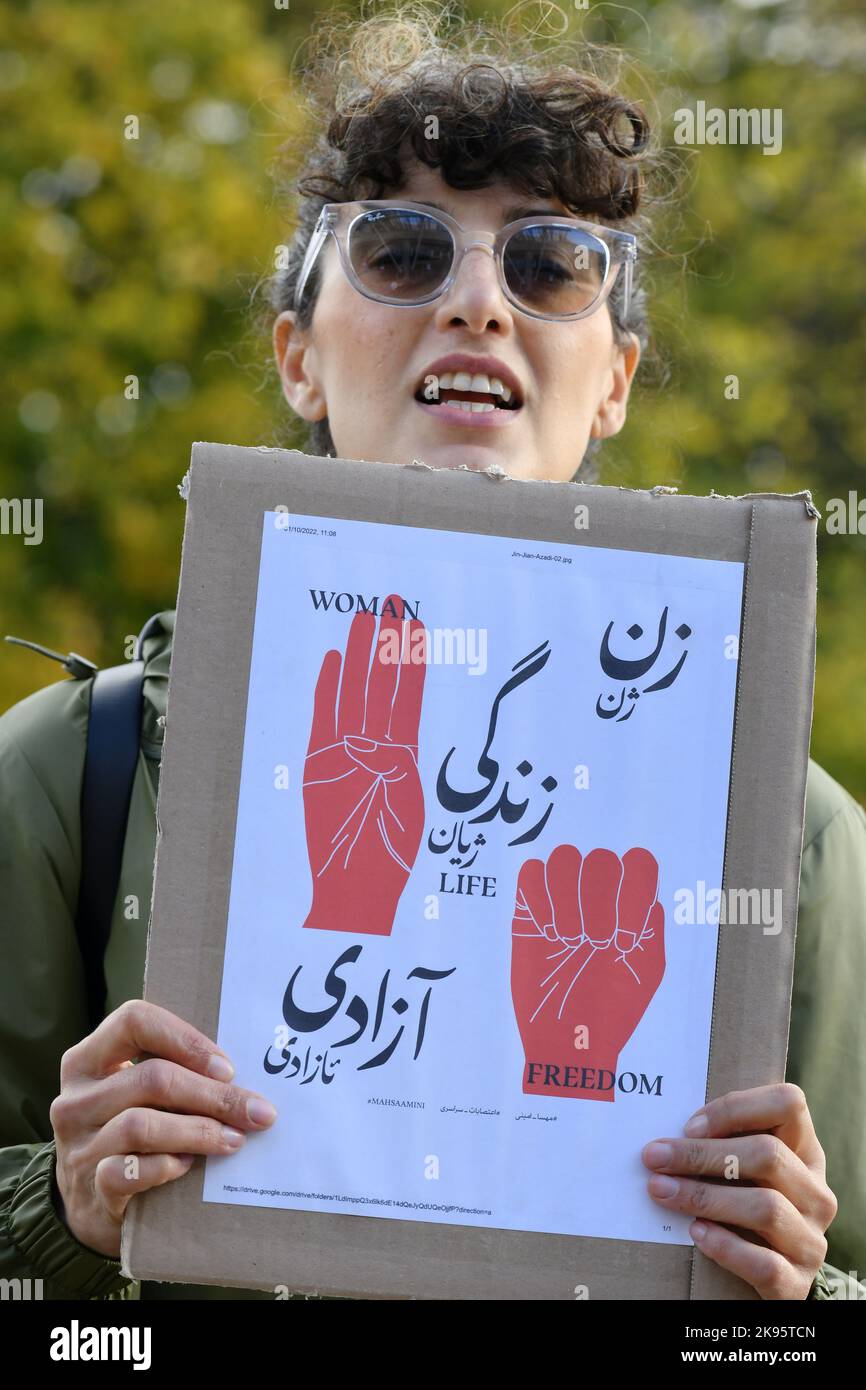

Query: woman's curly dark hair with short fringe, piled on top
left=253, top=0, right=663, bottom=481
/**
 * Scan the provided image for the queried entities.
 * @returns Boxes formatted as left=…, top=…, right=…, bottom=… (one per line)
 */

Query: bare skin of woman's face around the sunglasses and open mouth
left=274, top=161, right=639, bottom=480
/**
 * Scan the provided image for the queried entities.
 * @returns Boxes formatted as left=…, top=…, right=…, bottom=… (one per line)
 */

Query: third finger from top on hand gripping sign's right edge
left=648, top=1175, right=827, bottom=1269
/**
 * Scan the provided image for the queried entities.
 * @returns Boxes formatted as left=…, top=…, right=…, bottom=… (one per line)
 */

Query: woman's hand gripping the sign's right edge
left=641, top=1081, right=838, bottom=1298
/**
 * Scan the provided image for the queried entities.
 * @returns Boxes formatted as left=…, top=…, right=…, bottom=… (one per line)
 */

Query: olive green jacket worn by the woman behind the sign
left=0, top=612, right=866, bottom=1298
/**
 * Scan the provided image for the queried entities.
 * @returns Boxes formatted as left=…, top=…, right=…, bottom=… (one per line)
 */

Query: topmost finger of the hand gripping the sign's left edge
left=60, top=999, right=234, bottom=1090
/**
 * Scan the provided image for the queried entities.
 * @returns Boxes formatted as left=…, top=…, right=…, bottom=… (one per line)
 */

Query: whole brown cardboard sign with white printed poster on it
left=122, top=445, right=816, bottom=1300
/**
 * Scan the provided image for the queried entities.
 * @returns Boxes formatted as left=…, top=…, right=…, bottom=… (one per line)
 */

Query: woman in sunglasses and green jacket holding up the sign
left=0, top=11, right=866, bottom=1300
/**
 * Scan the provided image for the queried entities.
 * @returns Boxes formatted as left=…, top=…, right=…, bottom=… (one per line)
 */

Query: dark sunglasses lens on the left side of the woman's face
left=349, top=207, right=455, bottom=303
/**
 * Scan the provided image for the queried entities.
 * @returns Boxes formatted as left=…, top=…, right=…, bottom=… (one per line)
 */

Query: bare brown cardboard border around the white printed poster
left=122, top=443, right=816, bottom=1300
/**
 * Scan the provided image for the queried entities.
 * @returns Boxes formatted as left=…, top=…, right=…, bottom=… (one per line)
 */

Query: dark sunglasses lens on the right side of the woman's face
left=503, top=222, right=610, bottom=317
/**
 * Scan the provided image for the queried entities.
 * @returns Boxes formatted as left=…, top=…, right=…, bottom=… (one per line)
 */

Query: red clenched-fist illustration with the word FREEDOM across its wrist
left=512, top=845, right=664, bottom=1101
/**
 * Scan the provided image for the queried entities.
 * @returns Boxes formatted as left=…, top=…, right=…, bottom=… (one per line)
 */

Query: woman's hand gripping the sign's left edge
left=49, top=999, right=277, bottom=1259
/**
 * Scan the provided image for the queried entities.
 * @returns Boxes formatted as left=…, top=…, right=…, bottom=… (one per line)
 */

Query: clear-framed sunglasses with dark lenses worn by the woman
left=295, top=199, right=638, bottom=320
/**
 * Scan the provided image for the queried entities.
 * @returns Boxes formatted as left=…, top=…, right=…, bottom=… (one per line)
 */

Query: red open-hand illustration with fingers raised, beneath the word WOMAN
left=303, top=595, right=425, bottom=937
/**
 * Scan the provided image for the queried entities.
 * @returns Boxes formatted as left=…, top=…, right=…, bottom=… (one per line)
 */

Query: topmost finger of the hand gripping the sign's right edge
left=685, top=1081, right=826, bottom=1176
